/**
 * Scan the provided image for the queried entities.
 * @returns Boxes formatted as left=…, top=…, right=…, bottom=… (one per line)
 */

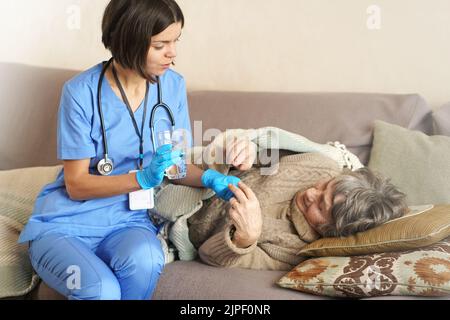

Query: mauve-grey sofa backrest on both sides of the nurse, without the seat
left=0, top=63, right=432, bottom=170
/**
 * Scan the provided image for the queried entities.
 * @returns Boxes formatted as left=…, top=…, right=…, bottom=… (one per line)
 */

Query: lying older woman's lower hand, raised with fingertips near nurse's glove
left=228, top=182, right=262, bottom=248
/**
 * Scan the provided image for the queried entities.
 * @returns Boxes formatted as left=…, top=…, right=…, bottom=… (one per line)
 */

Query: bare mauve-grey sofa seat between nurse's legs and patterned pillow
left=153, top=261, right=331, bottom=300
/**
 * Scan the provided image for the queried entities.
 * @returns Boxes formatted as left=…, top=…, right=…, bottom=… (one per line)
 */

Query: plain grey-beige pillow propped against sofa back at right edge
left=369, top=121, right=450, bottom=205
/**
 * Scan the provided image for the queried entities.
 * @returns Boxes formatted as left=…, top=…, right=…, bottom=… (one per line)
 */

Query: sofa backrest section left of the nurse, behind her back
left=0, top=63, right=76, bottom=170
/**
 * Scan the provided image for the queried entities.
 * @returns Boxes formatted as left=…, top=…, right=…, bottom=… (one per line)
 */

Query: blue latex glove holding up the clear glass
left=136, top=144, right=184, bottom=190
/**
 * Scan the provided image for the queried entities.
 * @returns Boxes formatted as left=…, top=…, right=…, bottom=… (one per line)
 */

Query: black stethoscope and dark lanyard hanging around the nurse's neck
left=97, top=58, right=175, bottom=176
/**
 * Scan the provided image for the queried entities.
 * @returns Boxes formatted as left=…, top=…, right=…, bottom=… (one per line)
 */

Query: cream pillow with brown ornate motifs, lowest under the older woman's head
left=278, top=238, right=450, bottom=298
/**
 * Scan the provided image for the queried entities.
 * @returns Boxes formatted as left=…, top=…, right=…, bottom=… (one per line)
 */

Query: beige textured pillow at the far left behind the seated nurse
left=0, top=166, right=61, bottom=298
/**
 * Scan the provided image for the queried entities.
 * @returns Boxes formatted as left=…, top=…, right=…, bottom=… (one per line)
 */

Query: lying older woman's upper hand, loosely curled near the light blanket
left=225, top=137, right=257, bottom=171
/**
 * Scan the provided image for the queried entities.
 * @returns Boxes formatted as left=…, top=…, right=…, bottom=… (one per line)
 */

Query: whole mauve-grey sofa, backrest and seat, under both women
left=0, top=64, right=448, bottom=300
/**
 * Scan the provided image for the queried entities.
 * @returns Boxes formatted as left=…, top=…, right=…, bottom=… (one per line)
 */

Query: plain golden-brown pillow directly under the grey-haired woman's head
left=299, top=205, right=450, bottom=257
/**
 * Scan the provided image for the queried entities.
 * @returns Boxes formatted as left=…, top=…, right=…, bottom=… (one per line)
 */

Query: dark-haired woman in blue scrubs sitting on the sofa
left=19, top=0, right=251, bottom=300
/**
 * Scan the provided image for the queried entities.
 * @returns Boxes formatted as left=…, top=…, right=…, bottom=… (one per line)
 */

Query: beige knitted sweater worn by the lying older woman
left=188, top=153, right=341, bottom=270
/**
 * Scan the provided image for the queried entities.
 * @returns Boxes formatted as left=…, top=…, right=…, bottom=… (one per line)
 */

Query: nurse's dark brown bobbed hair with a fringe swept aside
left=102, top=0, right=184, bottom=83
